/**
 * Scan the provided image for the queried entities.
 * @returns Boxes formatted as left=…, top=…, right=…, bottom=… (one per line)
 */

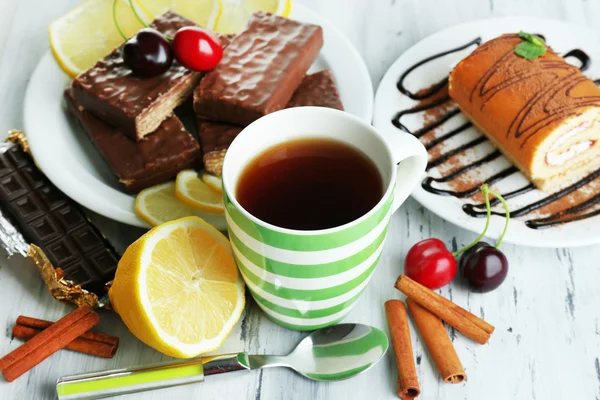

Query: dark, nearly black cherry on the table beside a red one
left=459, top=242, right=508, bottom=293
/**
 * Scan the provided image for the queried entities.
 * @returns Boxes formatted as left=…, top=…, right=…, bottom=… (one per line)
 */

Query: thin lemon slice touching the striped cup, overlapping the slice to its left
left=175, top=169, right=225, bottom=214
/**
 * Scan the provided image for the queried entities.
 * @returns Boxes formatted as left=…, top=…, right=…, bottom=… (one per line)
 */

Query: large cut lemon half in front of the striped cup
left=108, top=217, right=245, bottom=358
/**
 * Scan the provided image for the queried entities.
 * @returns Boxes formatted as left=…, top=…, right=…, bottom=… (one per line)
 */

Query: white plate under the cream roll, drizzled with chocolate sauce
left=374, top=18, right=600, bottom=247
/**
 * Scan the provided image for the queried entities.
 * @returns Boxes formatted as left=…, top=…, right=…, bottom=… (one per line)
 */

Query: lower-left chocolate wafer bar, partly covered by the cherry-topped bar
left=65, top=89, right=200, bottom=193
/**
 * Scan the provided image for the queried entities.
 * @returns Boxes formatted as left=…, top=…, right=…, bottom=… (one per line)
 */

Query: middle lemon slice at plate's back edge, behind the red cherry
left=138, top=0, right=221, bottom=30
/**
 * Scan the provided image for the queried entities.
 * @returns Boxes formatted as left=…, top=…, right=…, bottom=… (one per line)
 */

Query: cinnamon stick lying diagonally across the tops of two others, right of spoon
left=394, top=275, right=494, bottom=344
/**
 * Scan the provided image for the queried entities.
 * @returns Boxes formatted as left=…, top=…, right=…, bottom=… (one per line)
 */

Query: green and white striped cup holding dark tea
left=223, top=107, right=427, bottom=330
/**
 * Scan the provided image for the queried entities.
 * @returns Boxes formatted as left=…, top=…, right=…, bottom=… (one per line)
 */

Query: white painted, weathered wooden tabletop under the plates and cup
left=0, top=0, right=600, bottom=400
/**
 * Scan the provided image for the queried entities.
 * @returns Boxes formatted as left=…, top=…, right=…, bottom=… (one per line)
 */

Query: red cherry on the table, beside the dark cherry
left=404, top=239, right=456, bottom=289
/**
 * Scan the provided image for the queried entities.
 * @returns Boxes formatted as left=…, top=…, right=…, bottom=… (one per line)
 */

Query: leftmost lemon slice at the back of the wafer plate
left=48, top=0, right=148, bottom=77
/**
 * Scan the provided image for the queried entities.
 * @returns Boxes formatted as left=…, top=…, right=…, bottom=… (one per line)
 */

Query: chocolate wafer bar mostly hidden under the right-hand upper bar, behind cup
left=198, top=70, right=344, bottom=176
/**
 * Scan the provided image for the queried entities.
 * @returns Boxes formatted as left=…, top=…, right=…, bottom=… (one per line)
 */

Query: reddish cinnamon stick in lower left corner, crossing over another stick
left=0, top=305, right=100, bottom=382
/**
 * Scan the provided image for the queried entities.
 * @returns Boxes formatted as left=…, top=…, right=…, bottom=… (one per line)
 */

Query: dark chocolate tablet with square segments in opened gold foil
left=0, top=143, right=118, bottom=295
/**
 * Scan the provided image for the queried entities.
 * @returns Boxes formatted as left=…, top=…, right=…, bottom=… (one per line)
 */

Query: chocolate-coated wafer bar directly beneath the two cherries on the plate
left=72, top=12, right=229, bottom=140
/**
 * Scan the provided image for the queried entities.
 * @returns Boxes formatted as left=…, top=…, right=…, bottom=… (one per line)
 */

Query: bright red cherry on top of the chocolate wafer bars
left=173, top=26, right=223, bottom=71
